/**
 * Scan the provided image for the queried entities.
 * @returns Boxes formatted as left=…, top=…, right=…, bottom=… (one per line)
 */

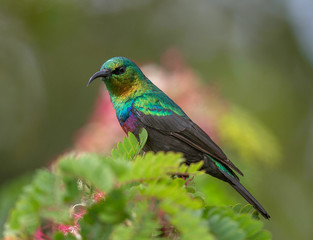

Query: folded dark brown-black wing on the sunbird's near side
left=132, top=94, right=243, bottom=176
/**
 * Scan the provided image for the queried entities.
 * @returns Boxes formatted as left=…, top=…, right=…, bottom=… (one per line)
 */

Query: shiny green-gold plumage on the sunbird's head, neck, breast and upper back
left=100, top=57, right=186, bottom=125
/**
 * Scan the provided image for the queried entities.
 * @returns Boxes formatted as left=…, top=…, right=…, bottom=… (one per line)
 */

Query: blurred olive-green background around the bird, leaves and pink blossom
left=0, top=0, right=313, bottom=240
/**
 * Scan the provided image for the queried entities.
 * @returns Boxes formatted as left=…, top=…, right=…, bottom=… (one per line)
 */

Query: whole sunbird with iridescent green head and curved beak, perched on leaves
left=87, top=57, right=270, bottom=219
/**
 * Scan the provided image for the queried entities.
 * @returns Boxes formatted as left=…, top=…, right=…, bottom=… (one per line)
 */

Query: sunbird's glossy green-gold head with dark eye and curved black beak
left=87, top=57, right=146, bottom=97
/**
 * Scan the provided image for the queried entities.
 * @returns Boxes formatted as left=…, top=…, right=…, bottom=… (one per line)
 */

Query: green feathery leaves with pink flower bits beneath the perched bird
left=5, top=129, right=271, bottom=240
